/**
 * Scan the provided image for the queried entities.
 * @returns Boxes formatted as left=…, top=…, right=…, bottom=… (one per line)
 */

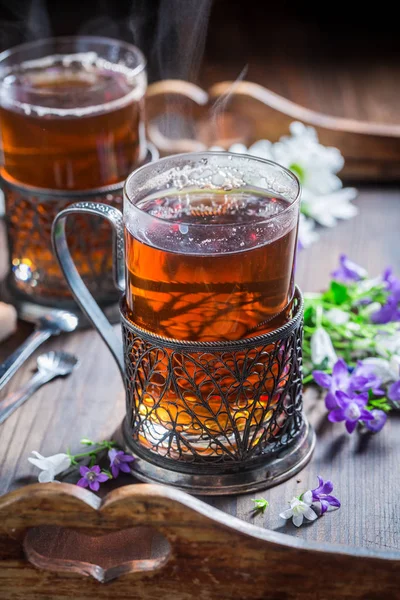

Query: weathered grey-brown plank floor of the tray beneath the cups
left=0, top=187, right=400, bottom=551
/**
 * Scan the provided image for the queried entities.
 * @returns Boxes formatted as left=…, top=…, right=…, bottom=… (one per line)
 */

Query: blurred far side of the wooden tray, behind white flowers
left=147, top=80, right=400, bottom=181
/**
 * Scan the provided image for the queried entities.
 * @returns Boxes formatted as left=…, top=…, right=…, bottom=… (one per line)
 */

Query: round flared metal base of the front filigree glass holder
left=122, top=420, right=316, bottom=496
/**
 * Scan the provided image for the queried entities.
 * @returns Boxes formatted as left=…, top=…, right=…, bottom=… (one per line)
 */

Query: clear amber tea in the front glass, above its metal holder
left=126, top=192, right=297, bottom=341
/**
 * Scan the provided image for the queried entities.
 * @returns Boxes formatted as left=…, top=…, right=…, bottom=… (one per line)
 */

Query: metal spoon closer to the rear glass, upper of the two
left=0, top=309, right=79, bottom=390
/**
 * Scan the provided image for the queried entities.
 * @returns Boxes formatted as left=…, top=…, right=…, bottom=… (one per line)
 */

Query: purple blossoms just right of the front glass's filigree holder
left=313, top=358, right=384, bottom=410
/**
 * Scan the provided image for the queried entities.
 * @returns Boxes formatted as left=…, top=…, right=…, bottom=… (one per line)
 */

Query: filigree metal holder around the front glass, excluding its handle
left=121, top=289, right=314, bottom=494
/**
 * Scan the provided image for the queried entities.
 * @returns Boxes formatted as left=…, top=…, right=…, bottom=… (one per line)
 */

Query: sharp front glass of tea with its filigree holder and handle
left=53, top=152, right=312, bottom=493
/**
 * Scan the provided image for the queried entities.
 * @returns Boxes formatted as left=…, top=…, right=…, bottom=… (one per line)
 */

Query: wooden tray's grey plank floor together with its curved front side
left=0, top=138, right=400, bottom=600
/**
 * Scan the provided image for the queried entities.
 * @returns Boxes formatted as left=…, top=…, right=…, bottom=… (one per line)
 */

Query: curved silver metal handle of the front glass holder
left=52, top=202, right=125, bottom=376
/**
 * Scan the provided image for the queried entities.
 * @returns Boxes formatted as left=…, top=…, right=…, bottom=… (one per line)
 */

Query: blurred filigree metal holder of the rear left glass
left=0, top=145, right=158, bottom=310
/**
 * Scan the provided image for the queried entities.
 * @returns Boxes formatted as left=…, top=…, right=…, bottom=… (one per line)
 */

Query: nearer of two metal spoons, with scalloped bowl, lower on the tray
left=0, top=352, right=78, bottom=424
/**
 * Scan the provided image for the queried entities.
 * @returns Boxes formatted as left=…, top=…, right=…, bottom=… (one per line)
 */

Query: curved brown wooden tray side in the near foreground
left=0, top=483, right=400, bottom=600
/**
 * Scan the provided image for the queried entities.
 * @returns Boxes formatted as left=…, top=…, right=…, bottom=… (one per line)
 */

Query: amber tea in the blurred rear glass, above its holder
left=0, top=52, right=146, bottom=190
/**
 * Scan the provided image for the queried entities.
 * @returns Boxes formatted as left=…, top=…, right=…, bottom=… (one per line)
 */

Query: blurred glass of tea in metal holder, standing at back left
left=0, top=36, right=151, bottom=308
